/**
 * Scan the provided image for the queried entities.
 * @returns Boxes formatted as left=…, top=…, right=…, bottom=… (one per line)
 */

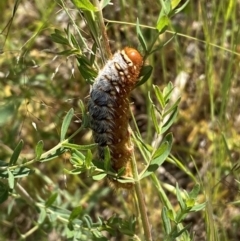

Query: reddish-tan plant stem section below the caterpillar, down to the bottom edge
left=131, top=137, right=152, bottom=241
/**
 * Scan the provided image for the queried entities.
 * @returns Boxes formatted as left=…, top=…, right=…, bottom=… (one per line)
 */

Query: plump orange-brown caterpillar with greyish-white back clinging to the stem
left=88, top=47, right=143, bottom=189
